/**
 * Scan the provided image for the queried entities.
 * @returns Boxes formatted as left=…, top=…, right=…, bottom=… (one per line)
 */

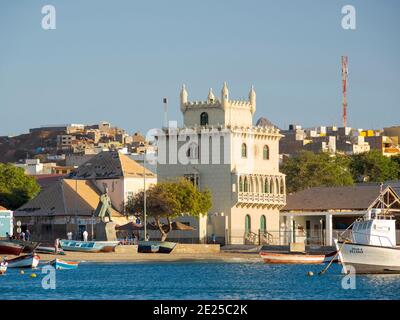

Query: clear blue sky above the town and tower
left=0, top=0, right=400, bottom=135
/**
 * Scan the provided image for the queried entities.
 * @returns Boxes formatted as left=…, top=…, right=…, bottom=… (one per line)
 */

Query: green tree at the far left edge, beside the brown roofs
left=0, top=163, right=40, bottom=210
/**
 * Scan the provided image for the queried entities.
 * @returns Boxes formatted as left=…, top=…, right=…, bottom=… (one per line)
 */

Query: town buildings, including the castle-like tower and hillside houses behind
left=0, top=83, right=400, bottom=246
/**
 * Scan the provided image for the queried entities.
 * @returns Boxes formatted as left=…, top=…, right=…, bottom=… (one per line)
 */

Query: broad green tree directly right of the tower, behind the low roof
left=281, top=151, right=353, bottom=192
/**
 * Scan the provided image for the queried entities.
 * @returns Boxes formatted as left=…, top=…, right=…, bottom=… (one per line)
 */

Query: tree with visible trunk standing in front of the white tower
left=126, top=179, right=212, bottom=241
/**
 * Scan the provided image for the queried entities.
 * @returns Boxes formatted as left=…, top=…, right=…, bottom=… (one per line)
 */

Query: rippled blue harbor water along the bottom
left=0, top=262, right=400, bottom=300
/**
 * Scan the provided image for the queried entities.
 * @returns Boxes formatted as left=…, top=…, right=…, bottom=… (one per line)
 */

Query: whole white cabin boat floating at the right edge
left=335, top=208, right=400, bottom=274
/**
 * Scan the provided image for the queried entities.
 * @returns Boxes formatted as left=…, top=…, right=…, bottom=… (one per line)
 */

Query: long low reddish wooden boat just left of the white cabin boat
left=260, top=251, right=338, bottom=264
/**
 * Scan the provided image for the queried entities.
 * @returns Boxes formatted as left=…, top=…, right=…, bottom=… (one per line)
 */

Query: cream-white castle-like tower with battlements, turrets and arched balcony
left=157, top=83, right=286, bottom=244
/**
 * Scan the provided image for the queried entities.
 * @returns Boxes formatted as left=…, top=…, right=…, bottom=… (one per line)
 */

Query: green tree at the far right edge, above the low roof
left=350, top=150, right=399, bottom=182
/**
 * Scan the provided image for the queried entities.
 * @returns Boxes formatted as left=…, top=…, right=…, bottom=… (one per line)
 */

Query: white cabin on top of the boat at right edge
left=352, top=209, right=396, bottom=247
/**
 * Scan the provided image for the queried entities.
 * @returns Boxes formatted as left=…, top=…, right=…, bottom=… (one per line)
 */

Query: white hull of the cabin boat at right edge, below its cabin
left=335, top=241, right=400, bottom=274
